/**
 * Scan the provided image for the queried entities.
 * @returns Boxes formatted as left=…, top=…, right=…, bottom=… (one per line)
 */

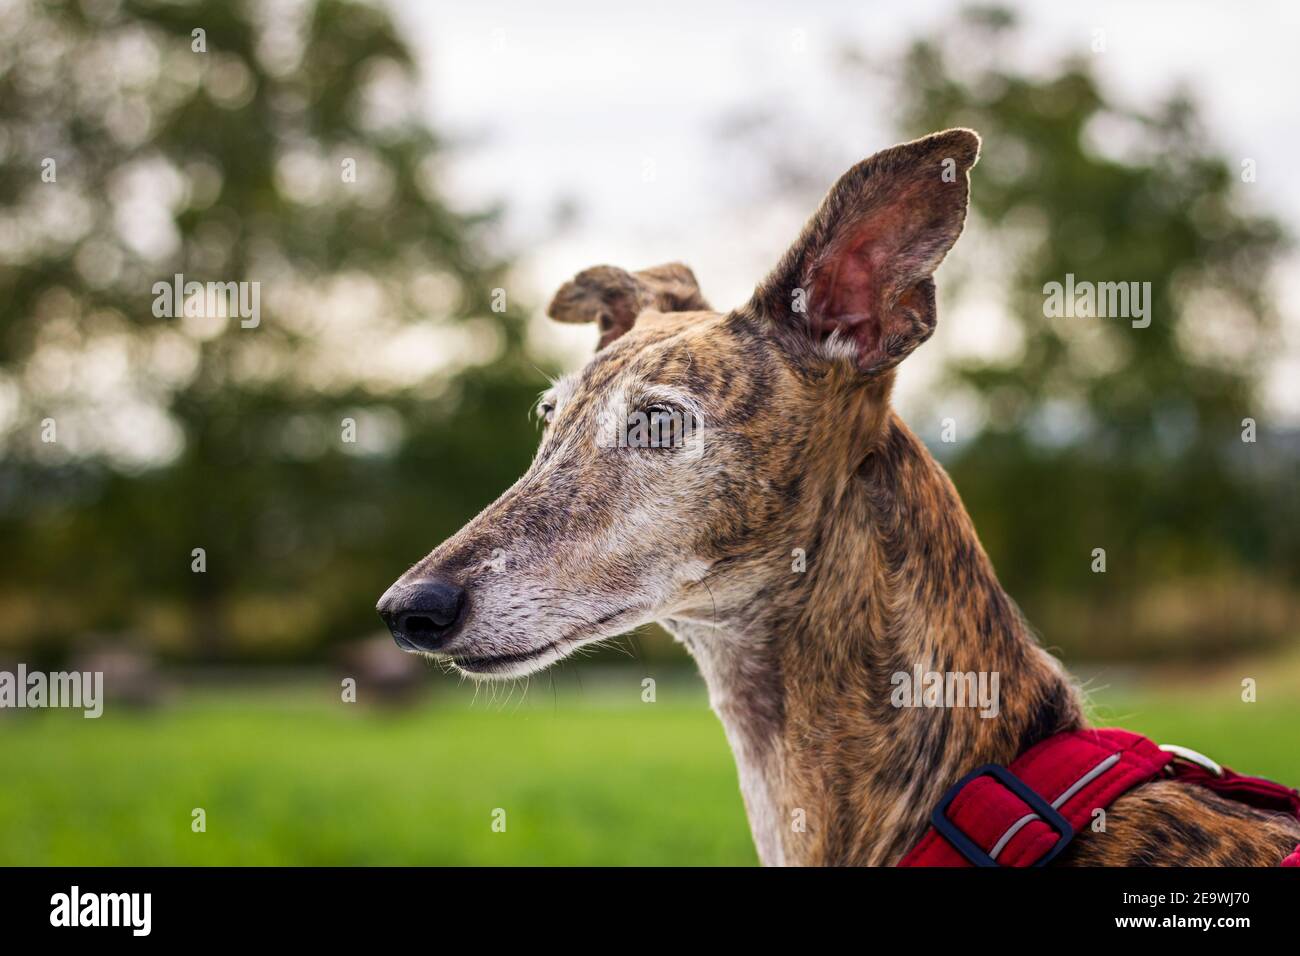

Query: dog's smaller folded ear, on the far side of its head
left=546, top=263, right=711, bottom=349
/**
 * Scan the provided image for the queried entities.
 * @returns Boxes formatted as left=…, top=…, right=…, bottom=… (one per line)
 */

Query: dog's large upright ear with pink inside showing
left=750, top=129, right=980, bottom=373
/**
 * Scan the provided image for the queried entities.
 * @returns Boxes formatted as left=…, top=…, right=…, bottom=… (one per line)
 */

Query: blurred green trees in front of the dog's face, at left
left=0, top=0, right=543, bottom=658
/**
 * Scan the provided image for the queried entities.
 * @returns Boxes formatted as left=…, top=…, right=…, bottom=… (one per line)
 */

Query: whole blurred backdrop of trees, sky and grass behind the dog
left=0, top=0, right=1300, bottom=864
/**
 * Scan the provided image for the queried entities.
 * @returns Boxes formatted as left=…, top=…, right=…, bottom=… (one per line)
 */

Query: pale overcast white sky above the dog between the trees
left=397, top=0, right=1300, bottom=423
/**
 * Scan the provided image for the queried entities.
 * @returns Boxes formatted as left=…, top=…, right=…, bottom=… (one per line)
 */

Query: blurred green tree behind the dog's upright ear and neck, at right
left=897, top=7, right=1300, bottom=653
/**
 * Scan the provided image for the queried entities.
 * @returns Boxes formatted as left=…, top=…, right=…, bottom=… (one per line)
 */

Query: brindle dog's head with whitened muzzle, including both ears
left=378, top=130, right=979, bottom=676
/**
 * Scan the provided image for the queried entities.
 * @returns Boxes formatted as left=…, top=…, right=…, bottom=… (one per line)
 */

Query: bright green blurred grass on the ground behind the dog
left=0, top=671, right=1300, bottom=865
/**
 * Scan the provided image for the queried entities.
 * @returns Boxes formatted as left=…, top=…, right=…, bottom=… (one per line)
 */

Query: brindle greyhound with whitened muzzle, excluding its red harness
left=378, top=129, right=1300, bottom=865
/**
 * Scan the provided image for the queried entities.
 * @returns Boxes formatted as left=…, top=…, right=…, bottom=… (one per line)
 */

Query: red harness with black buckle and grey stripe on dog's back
left=898, top=730, right=1300, bottom=866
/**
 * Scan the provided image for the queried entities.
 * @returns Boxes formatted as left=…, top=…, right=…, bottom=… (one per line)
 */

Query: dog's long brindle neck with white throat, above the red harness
left=666, top=412, right=1083, bottom=865
